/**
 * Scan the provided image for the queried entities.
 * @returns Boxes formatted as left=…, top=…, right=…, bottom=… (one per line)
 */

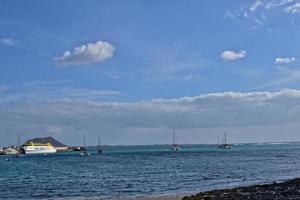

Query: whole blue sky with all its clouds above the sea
left=0, top=0, right=300, bottom=146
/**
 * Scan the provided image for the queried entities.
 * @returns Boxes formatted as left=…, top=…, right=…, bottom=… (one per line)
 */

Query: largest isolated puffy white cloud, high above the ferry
left=54, top=41, right=115, bottom=65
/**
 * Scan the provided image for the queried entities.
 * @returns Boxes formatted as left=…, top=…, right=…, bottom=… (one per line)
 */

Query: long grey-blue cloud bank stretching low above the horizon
left=0, top=89, right=300, bottom=145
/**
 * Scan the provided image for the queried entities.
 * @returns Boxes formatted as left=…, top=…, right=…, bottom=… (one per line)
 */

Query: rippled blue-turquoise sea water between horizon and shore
left=0, top=143, right=300, bottom=199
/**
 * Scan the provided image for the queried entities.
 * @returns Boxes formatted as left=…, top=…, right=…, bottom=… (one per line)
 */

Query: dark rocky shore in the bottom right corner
left=182, top=178, right=300, bottom=200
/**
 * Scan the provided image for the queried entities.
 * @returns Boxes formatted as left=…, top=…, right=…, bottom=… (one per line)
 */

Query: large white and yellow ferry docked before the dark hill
left=21, top=142, right=57, bottom=154
